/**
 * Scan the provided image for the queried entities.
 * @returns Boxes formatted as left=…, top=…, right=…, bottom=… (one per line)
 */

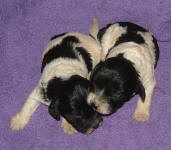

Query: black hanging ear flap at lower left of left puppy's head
left=48, top=100, right=60, bottom=121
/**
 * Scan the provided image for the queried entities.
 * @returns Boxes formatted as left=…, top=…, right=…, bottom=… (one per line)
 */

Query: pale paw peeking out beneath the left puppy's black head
left=61, top=118, right=77, bottom=135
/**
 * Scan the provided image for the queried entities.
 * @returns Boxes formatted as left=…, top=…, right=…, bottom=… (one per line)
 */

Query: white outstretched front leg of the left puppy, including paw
left=10, top=86, right=40, bottom=131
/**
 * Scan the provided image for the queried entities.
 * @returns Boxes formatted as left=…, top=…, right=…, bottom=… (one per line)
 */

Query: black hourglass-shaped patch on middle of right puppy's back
left=114, top=22, right=147, bottom=46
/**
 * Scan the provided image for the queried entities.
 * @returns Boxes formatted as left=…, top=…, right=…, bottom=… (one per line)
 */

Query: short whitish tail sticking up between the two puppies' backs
left=89, top=18, right=99, bottom=40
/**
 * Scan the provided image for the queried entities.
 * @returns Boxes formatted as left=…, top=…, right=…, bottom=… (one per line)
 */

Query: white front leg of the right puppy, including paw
left=133, top=79, right=156, bottom=122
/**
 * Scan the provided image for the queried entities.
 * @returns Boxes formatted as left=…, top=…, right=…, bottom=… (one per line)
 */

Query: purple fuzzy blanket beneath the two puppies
left=0, top=0, right=171, bottom=150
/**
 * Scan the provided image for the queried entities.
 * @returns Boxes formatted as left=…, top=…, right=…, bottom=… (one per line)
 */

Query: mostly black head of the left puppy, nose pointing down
left=47, top=75, right=102, bottom=134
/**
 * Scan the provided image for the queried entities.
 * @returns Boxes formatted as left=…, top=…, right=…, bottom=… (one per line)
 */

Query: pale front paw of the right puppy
left=132, top=111, right=150, bottom=122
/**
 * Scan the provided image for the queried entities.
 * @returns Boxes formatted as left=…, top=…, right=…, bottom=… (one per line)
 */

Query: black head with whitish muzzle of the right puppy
left=88, top=56, right=145, bottom=114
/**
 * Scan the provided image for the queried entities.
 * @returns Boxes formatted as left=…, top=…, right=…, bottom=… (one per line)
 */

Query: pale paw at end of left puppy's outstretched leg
left=10, top=113, right=29, bottom=131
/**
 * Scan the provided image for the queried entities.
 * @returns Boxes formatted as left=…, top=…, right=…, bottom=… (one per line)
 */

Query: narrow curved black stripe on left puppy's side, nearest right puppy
left=76, top=47, right=93, bottom=72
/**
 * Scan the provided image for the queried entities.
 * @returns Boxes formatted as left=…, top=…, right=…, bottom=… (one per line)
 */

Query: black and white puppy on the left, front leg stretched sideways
left=10, top=32, right=102, bottom=134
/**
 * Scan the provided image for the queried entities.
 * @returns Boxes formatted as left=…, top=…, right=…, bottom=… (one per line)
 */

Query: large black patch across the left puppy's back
left=41, top=36, right=79, bottom=72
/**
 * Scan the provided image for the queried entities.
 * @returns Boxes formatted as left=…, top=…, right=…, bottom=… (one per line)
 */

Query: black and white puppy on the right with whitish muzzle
left=88, top=19, right=159, bottom=121
